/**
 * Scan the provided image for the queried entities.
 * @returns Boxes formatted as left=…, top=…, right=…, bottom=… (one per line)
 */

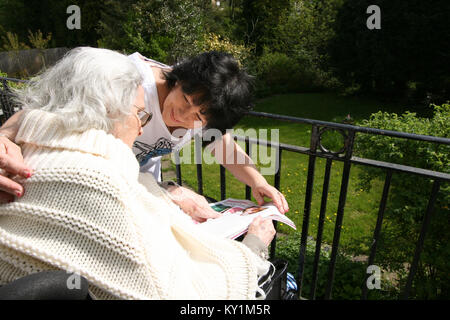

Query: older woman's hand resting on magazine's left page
left=167, top=186, right=220, bottom=222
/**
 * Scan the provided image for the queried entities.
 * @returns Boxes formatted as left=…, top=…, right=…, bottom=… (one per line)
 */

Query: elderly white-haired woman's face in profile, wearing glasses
left=113, top=86, right=145, bottom=148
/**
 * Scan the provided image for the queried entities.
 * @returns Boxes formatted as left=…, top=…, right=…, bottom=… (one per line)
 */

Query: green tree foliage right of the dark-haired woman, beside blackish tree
left=243, top=0, right=342, bottom=95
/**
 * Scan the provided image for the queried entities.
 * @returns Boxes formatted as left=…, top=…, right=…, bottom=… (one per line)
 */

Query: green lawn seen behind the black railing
left=168, top=93, right=404, bottom=254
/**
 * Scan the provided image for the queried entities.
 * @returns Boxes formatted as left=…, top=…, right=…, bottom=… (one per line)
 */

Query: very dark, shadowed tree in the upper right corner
left=328, top=0, right=450, bottom=100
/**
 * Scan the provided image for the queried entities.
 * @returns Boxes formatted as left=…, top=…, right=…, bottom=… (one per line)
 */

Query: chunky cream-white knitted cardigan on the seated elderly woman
left=0, top=110, right=268, bottom=299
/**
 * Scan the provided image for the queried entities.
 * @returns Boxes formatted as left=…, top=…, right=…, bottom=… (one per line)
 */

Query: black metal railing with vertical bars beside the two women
left=0, top=78, right=450, bottom=299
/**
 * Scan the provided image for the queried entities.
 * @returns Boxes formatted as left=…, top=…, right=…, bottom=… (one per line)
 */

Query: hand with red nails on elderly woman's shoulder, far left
left=0, top=136, right=33, bottom=203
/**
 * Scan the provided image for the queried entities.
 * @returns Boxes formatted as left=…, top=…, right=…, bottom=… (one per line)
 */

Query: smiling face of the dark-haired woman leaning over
left=162, top=82, right=206, bottom=129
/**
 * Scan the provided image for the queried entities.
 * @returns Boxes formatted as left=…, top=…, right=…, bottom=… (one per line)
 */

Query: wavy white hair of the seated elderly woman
left=15, top=47, right=143, bottom=132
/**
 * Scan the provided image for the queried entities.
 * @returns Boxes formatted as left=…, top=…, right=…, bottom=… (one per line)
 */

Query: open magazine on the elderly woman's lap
left=198, top=198, right=296, bottom=239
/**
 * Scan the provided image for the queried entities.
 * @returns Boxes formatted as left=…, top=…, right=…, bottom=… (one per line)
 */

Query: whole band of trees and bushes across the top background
left=0, top=0, right=450, bottom=104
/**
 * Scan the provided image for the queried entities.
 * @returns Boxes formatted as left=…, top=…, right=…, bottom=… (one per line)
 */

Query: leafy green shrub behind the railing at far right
left=355, top=104, right=450, bottom=299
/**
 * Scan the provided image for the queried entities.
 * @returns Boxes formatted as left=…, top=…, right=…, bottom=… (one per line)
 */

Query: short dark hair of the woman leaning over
left=164, top=51, right=253, bottom=134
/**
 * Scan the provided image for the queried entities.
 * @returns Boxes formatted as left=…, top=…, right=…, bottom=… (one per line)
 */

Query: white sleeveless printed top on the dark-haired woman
left=128, top=52, right=203, bottom=181
